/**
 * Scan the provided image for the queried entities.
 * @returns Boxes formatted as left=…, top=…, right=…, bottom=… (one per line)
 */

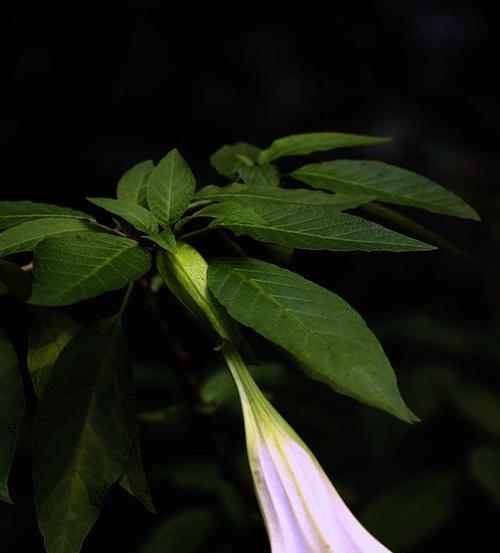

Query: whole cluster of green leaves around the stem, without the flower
left=0, top=133, right=478, bottom=553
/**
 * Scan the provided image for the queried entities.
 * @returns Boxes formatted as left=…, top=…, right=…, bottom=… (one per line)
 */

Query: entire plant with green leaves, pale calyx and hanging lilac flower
left=0, top=132, right=479, bottom=553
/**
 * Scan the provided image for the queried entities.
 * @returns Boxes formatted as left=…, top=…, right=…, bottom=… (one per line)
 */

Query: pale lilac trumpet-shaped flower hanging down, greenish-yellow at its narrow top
left=223, top=345, right=390, bottom=553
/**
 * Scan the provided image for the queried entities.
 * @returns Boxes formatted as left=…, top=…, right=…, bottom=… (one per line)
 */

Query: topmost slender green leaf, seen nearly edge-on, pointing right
left=259, top=132, right=391, bottom=164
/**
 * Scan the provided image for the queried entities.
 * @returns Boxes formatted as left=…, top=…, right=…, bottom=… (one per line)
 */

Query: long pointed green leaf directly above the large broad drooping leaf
left=194, top=198, right=435, bottom=252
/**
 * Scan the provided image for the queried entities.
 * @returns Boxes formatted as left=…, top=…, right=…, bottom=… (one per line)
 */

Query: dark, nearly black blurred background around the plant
left=0, top=0, right=500, bottom=552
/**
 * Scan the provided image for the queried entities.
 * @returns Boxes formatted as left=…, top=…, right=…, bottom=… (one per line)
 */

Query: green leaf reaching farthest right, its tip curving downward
left=291, top=159, right=479, bottom=221
